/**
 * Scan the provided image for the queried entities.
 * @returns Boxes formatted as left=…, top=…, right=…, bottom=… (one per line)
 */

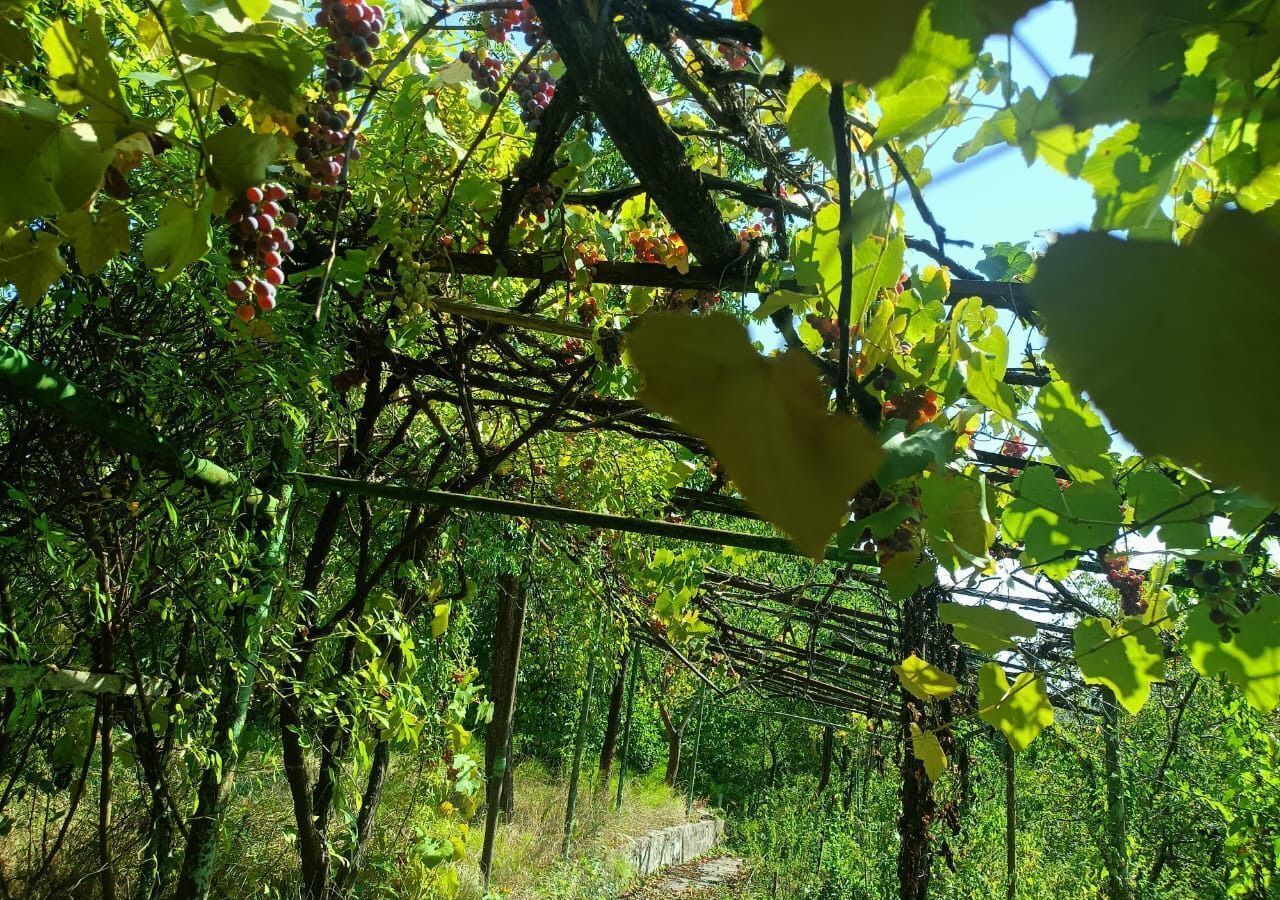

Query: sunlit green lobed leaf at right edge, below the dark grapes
left=1183, top=594, right=1280, bottom=713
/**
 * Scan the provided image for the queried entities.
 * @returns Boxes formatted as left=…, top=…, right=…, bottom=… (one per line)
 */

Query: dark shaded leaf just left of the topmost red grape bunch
left=174, top=27, right=314, bottom=109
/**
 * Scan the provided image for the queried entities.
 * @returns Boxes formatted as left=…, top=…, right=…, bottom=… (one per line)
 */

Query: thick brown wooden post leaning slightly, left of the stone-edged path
left=480, top=575, right=525, bottom=885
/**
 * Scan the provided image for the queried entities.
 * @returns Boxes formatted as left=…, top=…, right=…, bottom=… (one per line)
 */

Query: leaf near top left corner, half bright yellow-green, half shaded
left=40, top=9, right=129, bottom=122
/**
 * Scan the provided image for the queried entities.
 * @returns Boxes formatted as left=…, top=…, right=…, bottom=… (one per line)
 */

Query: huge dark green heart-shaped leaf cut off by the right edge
left=1030, top=213, right=1280, bottom=502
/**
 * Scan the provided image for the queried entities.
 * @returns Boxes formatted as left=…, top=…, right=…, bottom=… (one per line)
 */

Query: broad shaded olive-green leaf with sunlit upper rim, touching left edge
left=0, top=97, right=115, bottom=224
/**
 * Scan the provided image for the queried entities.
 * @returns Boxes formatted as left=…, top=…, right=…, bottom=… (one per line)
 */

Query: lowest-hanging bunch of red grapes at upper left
left=227, top=184, right=298, bottom=323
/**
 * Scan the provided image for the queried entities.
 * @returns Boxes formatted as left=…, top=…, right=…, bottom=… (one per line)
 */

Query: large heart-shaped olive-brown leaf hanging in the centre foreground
left=627, top=312, right=882, bottom=557
